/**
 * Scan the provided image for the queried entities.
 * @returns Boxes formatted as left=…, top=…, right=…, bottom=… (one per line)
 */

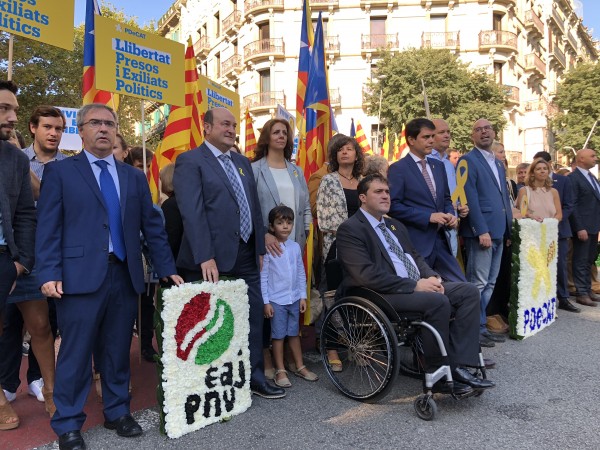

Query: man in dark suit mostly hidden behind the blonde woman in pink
left=532, top=152, right=580, bottom=313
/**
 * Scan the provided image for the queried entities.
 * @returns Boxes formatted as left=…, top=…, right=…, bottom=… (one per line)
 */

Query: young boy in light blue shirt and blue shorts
left=260, top=205, right=319, bottom=388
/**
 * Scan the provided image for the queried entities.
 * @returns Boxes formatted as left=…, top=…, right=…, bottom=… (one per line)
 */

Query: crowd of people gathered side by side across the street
left=0, top=77, right=600, bottom=449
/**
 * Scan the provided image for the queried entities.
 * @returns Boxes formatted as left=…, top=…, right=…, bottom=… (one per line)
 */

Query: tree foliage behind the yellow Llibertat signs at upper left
left=0, top=2, right=156, bottom=145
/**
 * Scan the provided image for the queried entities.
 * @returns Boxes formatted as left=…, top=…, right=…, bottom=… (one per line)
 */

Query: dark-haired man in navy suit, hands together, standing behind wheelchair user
left=388, top=119, right=467, bottom=281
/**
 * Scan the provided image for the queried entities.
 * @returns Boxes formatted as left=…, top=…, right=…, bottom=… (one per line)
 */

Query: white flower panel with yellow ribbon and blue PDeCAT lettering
left=511, top=219, right=558, bottom=339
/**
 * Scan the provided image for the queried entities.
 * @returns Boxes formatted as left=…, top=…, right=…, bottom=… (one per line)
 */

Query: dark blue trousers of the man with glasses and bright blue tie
left=50, top=263, right=137, bottom=436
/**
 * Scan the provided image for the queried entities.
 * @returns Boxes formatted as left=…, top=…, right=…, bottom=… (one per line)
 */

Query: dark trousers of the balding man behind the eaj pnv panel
left=181, top=241, right=266, bottom=384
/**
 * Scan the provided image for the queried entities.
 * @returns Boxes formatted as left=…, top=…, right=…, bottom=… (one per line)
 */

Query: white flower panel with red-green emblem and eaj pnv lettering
left=161, top=280, right=252, bottom=438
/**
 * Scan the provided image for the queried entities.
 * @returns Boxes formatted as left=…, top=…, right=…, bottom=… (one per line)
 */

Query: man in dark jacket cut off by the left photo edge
left=0, top=81, right=36, bottom=430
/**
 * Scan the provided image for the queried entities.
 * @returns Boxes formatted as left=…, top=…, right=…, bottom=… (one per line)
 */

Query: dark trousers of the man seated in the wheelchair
left=384, top=282, right=479, bottom=368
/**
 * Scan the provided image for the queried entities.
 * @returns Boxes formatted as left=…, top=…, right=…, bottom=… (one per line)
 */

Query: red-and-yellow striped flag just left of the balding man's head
left=148, top=37, right=204, bottom=203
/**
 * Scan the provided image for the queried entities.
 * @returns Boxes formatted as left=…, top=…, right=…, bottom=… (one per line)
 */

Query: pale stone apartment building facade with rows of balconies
left=147, top=0, right=598, bottom=166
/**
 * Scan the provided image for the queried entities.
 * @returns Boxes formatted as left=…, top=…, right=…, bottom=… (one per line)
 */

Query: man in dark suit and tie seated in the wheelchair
left=337, top=174, right=494, bottom=395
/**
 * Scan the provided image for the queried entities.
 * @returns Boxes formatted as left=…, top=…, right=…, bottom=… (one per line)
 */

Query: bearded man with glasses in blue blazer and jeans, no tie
left=459, top=119, right=512, bottom=347
